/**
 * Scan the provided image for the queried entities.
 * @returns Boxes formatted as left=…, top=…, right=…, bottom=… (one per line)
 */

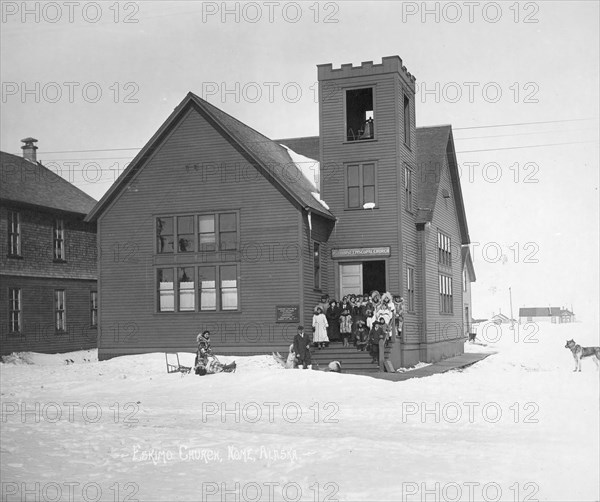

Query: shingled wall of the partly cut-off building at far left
left=0, top=205, right=97, bottom=355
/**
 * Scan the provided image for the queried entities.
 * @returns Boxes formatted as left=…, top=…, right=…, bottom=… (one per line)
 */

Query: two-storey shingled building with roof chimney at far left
left=0, top=138, right=98, bottom=355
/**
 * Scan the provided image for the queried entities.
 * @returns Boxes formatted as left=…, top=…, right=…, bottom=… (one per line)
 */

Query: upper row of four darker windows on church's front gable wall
left=156, top=212, right=239, bottom=254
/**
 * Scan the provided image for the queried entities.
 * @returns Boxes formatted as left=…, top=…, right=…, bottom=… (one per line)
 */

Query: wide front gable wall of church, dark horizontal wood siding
left=98, top=111, right=303, bottom=358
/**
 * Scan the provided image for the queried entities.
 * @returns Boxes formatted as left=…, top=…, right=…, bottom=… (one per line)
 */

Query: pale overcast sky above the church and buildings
left=0, top=1, right=600, bottom=322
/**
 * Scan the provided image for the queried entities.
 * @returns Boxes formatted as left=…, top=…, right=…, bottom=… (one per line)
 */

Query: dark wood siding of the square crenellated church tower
left=320, top=68, right=416, bottom=296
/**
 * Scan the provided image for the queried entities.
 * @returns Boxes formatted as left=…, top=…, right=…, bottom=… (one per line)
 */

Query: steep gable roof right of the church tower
left=416, top=125, right=471, bottom=244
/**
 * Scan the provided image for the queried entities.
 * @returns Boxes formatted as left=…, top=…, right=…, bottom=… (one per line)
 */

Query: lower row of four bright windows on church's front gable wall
left=157, top=264, right=239, bottom=312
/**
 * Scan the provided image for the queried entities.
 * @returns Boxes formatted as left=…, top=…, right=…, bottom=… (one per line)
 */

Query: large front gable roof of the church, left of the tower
left=86, top=92, right=335, bottom=221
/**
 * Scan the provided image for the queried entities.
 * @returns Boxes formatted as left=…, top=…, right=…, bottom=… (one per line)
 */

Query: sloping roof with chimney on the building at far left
left=0, top=152, right=96, bottom=215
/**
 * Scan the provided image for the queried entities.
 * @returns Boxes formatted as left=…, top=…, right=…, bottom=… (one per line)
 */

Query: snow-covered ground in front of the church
left=0, top=323, right=600, bottom=502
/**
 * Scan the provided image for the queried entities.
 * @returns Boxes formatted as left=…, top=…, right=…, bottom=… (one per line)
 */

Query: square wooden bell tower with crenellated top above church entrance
left=318, top=56, right=416, bottom=302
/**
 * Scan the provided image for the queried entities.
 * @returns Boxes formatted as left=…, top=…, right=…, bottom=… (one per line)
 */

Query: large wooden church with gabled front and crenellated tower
left=87, top=56, right=474, bottom=366
